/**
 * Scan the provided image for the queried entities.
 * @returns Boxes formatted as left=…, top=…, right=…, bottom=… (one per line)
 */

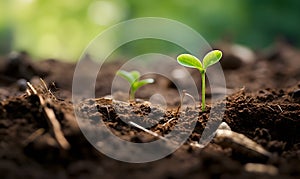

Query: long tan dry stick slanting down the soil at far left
left=27, top=82, right=70, bottom=150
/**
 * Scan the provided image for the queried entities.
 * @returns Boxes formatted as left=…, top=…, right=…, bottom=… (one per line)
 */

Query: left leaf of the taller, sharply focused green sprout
left=177, top=54, right=203, bottom=70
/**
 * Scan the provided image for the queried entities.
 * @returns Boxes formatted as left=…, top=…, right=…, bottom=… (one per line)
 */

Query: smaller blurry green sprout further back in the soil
left=117, top=70, right=154, bottom=100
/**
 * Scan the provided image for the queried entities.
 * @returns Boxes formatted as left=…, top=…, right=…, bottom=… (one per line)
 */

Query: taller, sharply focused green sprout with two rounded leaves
left=177, top=50, right=222, bottom=112
